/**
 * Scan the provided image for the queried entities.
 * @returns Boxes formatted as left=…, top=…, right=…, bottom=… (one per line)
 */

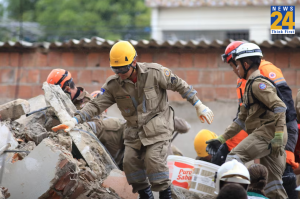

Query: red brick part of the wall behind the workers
left=0, top=47, right=300, bottom=102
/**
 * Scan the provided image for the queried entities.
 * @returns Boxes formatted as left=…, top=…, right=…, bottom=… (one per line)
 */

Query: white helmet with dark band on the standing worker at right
left=232, top=43, right=263, bottom=60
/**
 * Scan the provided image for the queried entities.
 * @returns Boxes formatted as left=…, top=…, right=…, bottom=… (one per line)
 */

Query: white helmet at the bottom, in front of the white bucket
left=215, top=160, right=250, bottom=194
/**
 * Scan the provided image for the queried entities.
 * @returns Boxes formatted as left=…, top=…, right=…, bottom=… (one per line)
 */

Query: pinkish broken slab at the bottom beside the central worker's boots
left=102, top=169, right=138, bottom=199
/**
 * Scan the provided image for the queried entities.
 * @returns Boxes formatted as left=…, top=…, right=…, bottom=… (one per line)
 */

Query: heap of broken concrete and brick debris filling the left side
left=0, top=83, right=214, bottom=199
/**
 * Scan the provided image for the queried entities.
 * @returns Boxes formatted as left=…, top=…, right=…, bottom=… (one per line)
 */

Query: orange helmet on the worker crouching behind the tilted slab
left=47, top=69, right=73, bottom=88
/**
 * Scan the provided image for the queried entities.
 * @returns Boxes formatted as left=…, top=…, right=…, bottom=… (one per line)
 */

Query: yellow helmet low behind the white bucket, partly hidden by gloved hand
left=194, top=129, right=218, bottom=157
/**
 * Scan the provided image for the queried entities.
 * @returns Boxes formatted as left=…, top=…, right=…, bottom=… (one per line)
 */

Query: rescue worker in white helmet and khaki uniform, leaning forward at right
left=207, top=43, right=287, bottom=199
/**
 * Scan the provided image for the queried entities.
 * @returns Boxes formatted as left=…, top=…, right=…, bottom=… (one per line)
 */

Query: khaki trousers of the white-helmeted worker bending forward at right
left=226, top=132, right=288, bottom=199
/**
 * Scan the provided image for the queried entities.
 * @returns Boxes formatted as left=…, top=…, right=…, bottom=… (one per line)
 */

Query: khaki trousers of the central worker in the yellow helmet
left=123, top=141, right=171, bottom=193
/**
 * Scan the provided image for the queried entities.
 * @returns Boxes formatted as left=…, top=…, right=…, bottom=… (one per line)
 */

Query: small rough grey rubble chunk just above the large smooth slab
left=24, top=123, right=48, bottom=145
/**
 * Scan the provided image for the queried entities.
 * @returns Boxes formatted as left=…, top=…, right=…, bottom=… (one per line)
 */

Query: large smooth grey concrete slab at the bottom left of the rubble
left=3, top=139, right=79, bottom=199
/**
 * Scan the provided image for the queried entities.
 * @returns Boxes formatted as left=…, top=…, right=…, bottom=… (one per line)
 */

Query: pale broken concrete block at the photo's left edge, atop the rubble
left=0, top=99, right=30, bottom=120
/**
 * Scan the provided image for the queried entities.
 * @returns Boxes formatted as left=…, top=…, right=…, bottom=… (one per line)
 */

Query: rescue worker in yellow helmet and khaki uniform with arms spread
left=52, top=41, right=213, bottom=199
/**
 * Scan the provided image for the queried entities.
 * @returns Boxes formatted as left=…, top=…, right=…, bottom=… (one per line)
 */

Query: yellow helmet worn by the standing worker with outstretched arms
left=109, top=41, right=136, bottom=67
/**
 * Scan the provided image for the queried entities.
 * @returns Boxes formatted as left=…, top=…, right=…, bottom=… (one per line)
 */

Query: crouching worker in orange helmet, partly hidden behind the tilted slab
left=47, top=69, right=126, bottom=169
